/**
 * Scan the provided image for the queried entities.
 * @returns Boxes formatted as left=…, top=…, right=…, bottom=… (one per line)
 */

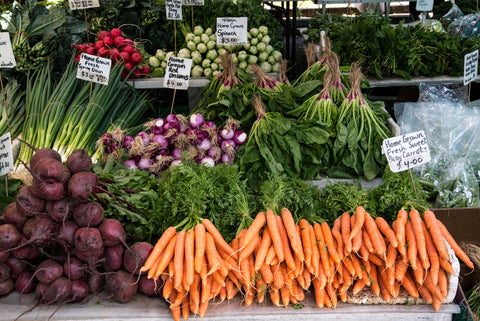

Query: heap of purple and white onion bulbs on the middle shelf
left=99, top=113, right=247, bottom=174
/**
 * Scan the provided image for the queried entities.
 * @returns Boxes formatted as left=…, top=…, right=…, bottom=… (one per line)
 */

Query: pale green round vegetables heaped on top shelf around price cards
left=148, top=26, right=282, bottom=78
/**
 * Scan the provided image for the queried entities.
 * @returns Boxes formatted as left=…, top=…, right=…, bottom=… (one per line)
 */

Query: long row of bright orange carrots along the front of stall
left=141, top=207, right=473, bottom=320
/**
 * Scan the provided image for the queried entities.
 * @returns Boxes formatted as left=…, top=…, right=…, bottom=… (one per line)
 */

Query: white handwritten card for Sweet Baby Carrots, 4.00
left=382, top=130, right=431, bottom=173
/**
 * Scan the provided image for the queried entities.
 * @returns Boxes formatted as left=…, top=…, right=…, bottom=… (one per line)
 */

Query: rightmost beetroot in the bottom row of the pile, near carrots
left=105, top=270, right=138, bottom=303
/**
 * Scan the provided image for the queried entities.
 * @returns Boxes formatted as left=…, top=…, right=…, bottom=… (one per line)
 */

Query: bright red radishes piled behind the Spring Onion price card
left=74, top=28, right=150, bottom=79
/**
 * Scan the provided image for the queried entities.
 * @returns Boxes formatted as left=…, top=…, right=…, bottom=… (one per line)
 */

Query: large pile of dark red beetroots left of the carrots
left=0, top=148, right=158, bottom=312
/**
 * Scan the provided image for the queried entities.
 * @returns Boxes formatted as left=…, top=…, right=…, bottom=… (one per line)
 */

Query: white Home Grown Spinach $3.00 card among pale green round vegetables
left=217, top=17, right=248, bottom=45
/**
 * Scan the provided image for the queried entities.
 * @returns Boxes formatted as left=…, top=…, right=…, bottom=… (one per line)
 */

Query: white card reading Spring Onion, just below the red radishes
left=77, top=53, right=112, bottom=85
